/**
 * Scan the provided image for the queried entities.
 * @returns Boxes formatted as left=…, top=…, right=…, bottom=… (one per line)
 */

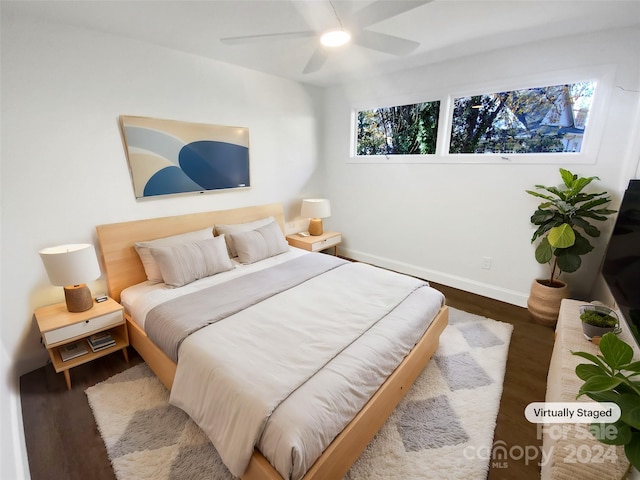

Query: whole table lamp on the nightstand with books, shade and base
left=38, top=243, right=100, bottom=312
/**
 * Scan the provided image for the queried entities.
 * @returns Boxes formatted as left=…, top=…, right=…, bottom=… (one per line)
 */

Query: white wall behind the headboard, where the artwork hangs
left=0, top=10, right=320, bottom=478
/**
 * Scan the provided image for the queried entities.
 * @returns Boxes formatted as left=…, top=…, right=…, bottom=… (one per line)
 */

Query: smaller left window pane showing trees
left=356, top=101, right=440, bottom=155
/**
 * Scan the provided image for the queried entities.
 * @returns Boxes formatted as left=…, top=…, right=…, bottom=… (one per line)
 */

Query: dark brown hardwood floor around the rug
left=20, top=284, right=553, bottom=480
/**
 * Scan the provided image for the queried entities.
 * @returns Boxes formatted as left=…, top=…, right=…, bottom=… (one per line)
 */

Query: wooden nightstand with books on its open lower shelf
left=35, top=298, right=129, bottom=389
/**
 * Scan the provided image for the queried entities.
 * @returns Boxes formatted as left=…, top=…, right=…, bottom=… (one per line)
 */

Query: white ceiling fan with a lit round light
left=220, top=0, right=431, bottom=74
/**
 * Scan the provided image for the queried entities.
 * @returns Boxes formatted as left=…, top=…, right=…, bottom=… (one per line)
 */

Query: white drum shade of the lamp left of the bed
left=38, top=243, right=100, bottom=287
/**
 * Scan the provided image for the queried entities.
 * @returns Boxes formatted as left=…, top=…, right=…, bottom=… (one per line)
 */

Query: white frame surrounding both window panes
left=347, top=65, right=616, bottom=165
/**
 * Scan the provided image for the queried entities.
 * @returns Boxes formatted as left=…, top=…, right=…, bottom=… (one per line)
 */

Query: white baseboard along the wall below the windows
left=340, top=247, right=529, bottom=307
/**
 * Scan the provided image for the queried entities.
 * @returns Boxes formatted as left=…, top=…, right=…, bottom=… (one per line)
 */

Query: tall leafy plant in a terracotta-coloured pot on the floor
left=526, top=168, right=615, bottom=325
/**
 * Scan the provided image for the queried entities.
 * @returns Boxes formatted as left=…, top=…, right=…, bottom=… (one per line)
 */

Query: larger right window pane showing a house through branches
left=449, top=82, right=596, bottom=154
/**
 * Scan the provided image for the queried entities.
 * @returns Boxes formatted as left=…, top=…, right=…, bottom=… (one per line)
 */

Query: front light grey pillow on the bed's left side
left=150, top=236, right=232, bottom=287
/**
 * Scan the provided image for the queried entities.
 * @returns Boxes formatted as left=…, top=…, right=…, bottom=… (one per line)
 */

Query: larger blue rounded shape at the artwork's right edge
left=179, top=140, right=249, bottom=190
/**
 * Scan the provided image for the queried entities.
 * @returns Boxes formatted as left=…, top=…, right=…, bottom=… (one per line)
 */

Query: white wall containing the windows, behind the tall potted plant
left=324, top=29, right=640, bottom=306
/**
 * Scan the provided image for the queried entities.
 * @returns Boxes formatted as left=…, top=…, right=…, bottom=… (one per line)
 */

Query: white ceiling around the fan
left=2, top=0, right=640, bottom=85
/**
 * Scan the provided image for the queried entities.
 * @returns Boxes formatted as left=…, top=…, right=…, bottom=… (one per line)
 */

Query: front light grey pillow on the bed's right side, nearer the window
left=231, top=222, right=289, bottom=263
